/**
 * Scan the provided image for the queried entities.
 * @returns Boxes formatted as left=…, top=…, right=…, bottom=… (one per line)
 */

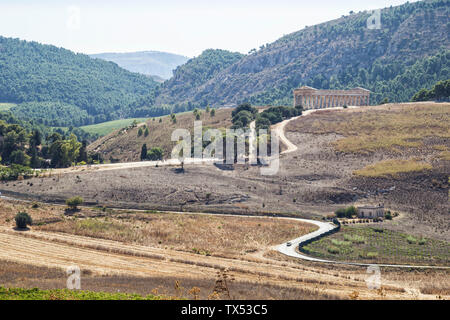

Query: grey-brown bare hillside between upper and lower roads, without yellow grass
left=0, top=104, right=450, bottom=239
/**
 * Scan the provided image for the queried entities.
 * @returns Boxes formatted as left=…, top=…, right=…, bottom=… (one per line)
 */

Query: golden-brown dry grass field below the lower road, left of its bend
left=0, top=200, right=316, bottom=256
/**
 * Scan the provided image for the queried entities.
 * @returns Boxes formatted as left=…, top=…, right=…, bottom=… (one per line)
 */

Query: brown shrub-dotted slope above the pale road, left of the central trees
left=88, top=109, right=232, bottom=162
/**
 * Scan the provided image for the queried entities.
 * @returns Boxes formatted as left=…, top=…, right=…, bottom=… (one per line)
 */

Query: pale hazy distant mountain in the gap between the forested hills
left=90, top=51, right=189, bottom=80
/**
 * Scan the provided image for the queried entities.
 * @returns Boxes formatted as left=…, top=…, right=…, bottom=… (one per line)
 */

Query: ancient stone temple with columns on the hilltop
left=294, top=86, right=370, bottom=110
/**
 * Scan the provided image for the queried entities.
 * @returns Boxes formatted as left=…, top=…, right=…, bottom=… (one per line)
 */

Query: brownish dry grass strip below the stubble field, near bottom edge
left=0, top=260, right=339, bottom=300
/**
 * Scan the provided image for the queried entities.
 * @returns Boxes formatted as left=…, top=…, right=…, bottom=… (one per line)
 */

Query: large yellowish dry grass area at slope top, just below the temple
left=289, top=103, right=450, bottom=154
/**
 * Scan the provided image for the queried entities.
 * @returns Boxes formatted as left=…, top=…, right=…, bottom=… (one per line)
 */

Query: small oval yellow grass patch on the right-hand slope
left=354, top=160, right=433, bottom=178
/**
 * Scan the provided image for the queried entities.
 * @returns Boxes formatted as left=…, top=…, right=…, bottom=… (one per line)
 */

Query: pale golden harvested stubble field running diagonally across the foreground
left=0, top=222, right=445, bottom=299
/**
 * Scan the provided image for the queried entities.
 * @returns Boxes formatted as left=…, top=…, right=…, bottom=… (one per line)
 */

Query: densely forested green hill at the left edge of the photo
left=0, top=37, right=157, bottom=125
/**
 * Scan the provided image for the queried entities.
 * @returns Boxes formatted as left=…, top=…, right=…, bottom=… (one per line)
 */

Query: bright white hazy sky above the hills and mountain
left=0, top=0, right=416, bottom=57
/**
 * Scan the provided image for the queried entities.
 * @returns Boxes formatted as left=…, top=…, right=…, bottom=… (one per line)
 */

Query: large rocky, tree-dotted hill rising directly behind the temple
left=162, top=0, right=450, bottom=105
